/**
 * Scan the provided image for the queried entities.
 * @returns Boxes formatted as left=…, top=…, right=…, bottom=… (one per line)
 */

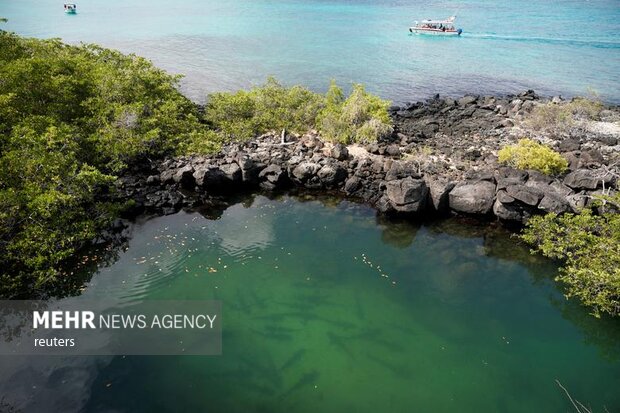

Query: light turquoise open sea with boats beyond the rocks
left=0, top=0, right=620, bottom=103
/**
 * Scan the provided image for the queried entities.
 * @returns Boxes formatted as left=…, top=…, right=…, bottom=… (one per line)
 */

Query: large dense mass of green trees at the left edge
left=0, top=31, right=207, bottom=297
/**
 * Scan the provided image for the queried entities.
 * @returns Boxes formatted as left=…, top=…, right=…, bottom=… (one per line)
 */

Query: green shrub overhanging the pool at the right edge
left=522, top=195, right=620, bottom=317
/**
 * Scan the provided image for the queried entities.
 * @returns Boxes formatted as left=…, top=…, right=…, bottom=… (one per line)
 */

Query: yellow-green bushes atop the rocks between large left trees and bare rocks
left=205, top=78, right=392, bottom=143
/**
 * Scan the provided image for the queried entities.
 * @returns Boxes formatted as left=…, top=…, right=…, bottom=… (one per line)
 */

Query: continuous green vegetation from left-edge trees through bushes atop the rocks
left=0, top=30, right=391, bottom=297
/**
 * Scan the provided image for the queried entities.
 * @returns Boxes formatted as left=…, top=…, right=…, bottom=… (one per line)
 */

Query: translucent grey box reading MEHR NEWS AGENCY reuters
left=0, top=298, right=222, bottom=356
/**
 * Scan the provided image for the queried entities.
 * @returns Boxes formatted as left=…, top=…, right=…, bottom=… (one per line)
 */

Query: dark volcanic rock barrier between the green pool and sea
left=109, top=91, right=620, bottom=238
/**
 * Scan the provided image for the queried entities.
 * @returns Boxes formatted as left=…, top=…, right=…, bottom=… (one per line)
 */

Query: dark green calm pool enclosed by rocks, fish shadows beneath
left=0, top=196, right=620, bottom=412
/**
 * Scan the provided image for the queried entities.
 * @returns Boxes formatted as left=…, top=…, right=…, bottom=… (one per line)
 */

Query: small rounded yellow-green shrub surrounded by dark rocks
left=498, top=139, right=568, bottom=175
